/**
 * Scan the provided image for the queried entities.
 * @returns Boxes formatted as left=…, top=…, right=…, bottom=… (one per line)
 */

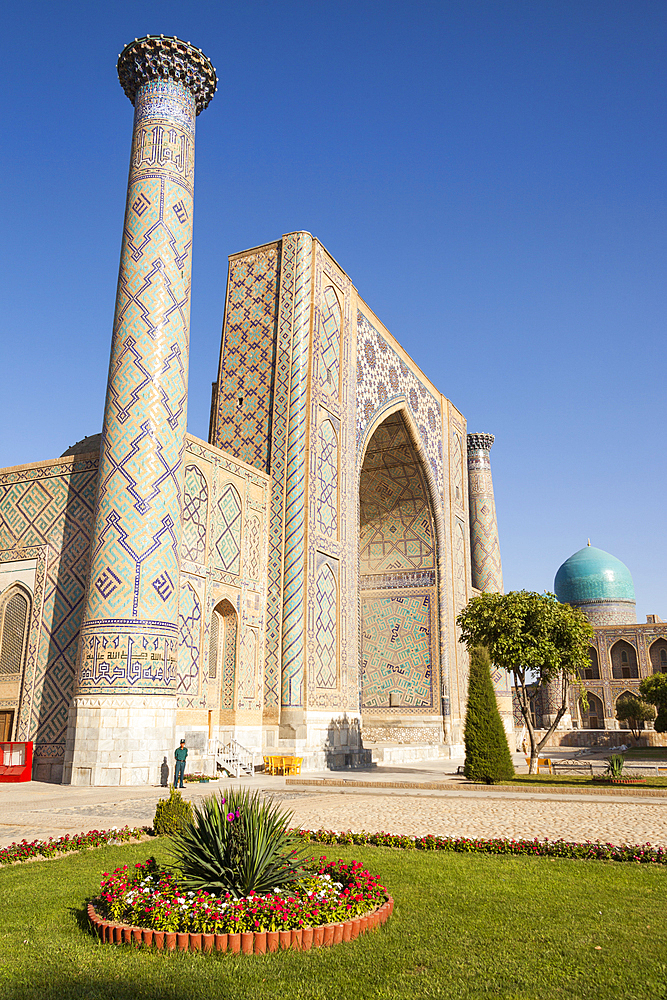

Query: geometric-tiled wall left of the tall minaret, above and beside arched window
left=0, top=456, right=98, bottom=755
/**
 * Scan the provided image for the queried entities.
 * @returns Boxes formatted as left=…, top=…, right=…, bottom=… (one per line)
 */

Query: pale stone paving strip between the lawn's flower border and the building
left=0, top=785, right=667, bottom=846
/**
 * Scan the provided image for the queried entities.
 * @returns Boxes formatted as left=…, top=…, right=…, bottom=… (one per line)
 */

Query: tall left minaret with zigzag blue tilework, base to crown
left=64, top=35, right=217, bottom=785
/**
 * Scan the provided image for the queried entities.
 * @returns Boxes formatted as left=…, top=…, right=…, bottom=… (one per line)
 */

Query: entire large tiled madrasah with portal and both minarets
left=0, top=36, right=512, bottom=785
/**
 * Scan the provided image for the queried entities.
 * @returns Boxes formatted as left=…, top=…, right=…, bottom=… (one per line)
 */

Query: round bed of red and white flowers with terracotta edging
left=89, top=857, right=393, bottom=952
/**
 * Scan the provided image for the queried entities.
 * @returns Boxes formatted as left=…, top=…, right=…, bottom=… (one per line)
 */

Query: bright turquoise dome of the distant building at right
left=554, top=545, right=635, bottom=604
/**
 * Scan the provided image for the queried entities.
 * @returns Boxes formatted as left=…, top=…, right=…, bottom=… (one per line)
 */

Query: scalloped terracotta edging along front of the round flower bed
left=88, top=896, right=394, bottom=955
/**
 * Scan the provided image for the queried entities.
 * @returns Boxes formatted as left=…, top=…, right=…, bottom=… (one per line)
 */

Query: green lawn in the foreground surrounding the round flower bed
left=0, top=840, right=667, bottom=1000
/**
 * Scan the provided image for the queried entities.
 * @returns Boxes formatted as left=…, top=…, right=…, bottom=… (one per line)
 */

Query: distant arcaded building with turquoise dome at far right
left=535, top=541, right=667, bottom=730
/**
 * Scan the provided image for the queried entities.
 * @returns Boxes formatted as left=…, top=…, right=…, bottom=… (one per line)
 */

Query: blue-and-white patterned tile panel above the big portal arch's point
left=357, top=312, right=443, bottom=493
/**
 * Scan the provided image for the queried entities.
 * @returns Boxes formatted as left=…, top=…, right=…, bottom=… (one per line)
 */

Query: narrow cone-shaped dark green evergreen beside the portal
left=463, top=646, right=514, bottom=785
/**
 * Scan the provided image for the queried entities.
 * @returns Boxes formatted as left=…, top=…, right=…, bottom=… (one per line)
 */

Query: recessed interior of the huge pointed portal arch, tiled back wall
left=359, top=411, right=439, bottom=726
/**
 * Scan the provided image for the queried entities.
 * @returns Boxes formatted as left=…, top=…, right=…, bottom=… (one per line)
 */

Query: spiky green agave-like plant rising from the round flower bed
left=170, top=789, right=306, bottom=899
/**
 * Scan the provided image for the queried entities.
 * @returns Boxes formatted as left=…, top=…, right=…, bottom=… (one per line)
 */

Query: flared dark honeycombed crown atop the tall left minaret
left=117, top=35, right=218, bottom=114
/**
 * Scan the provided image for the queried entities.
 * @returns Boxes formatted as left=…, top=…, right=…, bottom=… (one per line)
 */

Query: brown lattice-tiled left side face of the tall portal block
left=212, top=245, right=280, bottom=472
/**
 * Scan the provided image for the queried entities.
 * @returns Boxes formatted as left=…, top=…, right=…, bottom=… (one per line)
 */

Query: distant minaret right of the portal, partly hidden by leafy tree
left=468, top=434, right=514, bottom=749
